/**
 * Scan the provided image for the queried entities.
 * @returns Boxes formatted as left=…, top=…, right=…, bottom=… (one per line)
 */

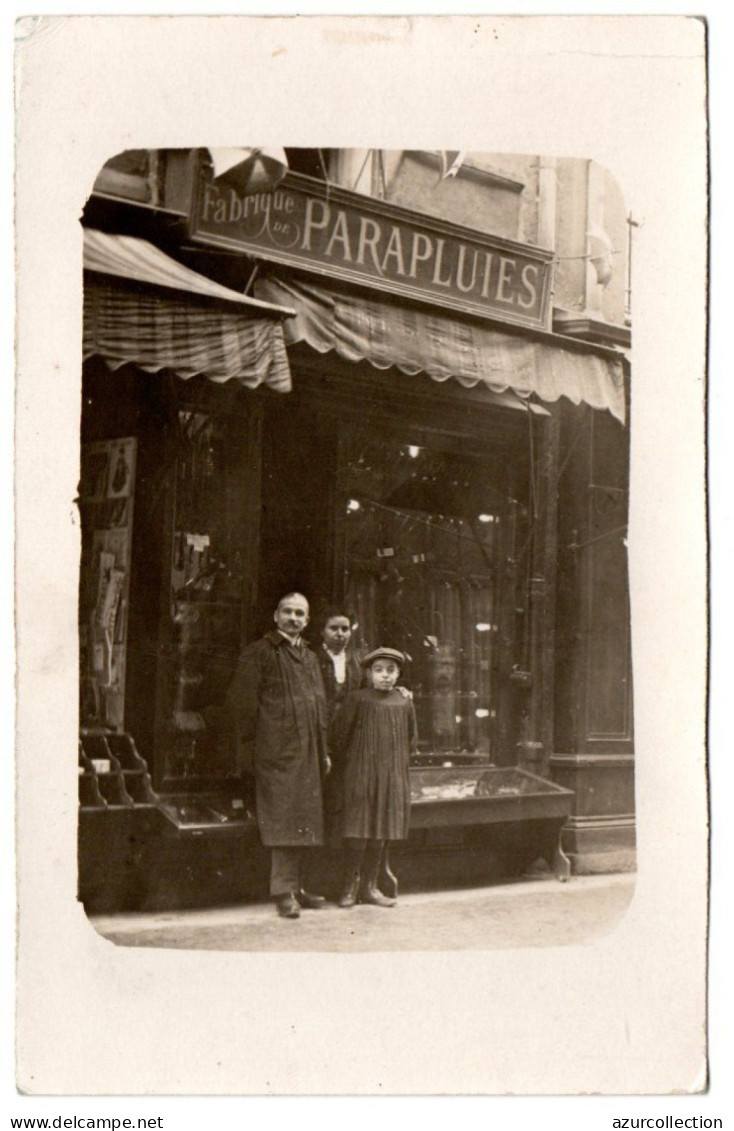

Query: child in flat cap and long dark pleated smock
left=333, top=648, right=417, bottom=907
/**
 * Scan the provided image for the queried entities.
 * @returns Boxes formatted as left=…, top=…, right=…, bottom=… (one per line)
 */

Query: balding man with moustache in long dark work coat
left=176, top=593, right=330, bottom=918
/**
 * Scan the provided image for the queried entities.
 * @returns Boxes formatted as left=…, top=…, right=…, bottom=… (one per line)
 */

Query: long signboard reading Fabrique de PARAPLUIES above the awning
left=190, top=173, right=552, bottom=329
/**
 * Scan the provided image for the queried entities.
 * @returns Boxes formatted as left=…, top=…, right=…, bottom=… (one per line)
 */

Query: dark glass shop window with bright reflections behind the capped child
left=343, top=439, right=521, bottom=765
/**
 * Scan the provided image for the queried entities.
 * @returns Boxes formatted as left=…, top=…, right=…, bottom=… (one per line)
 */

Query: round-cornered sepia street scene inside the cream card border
left=79, top=147, right=638, bottom=950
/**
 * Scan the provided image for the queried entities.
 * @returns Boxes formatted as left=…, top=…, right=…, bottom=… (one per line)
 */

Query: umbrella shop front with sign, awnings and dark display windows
left=79, top=152, right=624, bottom=909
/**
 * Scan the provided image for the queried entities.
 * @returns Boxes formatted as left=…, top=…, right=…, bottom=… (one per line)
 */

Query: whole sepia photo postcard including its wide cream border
left=11, top=16, right=708, bottom=1099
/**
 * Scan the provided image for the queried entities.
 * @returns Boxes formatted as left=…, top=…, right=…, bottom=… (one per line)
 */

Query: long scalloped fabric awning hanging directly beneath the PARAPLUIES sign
left=257, top=275, right=624, bottom=423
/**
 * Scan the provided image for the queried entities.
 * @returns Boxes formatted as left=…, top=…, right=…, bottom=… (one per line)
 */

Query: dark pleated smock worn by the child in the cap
left=334, top=688, right=417, bottom=840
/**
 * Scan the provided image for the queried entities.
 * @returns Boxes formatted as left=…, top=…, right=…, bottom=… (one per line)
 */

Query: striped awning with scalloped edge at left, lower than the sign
left=84, top=228, right=294, bottom=392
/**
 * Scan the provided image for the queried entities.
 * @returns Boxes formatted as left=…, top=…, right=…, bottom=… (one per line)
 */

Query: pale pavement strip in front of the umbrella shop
left=89, top=873, right=634, bottom=952
